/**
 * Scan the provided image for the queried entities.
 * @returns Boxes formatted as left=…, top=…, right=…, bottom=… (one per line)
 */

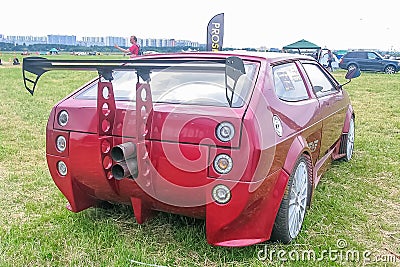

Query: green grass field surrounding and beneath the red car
left=0, top=54, right=400, bottom=266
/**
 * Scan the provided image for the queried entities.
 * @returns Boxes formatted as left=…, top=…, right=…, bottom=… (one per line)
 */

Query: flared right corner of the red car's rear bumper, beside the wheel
left=206, top=170, right=289, bottom=247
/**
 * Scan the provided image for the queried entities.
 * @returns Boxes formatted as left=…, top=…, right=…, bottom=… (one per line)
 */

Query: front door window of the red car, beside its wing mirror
left=303, top=63, right=338, bottom=97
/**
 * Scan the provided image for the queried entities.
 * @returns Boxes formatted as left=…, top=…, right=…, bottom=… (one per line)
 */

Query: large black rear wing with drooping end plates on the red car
left=22, top=57, right=245, bottom=101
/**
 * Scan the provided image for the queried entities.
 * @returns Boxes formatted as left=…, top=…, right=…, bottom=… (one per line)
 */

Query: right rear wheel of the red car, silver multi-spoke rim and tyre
left=271, top=155, right=312, bottom=244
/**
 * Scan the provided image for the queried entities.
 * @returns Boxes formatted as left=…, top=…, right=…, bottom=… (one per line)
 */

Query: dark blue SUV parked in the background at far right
left=339, top=51, right=400, bottom=74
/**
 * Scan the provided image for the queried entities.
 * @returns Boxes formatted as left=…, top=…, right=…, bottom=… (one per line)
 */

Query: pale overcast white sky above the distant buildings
left=0, top=0, right=400, bottom=51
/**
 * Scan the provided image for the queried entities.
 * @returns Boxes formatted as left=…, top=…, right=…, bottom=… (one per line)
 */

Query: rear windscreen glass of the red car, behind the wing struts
left=76, top=63, right=257, bottom=107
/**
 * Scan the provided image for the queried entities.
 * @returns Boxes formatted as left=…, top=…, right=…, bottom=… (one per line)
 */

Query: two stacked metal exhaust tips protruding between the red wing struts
left=111, top=142, right=138, bottom=180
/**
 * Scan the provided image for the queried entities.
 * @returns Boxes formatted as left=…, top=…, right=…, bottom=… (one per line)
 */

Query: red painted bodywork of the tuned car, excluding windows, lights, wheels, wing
left=25, top=53, right=354, bottom=246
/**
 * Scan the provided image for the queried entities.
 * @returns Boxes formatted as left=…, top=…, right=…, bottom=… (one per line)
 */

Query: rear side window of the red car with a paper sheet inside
left=272, top=63, right=308, bottom=101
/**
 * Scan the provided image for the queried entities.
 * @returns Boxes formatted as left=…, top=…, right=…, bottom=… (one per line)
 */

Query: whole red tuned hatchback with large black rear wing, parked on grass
left=23, top=52, right=360, bottom=246
